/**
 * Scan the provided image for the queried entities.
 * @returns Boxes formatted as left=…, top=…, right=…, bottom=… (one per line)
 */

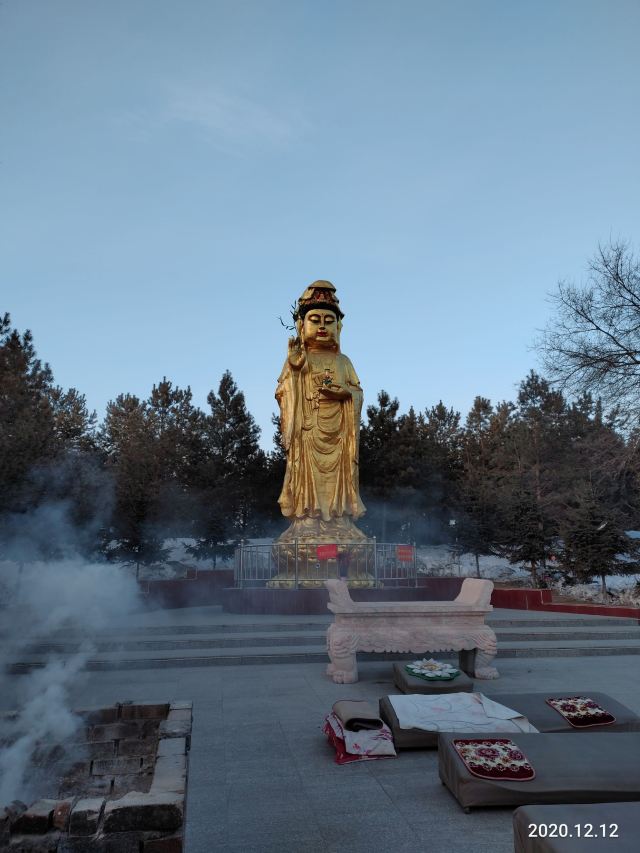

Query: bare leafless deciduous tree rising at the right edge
left=538, top=242, right=640, bottom=426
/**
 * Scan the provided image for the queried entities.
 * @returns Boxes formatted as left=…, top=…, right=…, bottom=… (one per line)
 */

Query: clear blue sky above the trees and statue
left=0, top=0, right=640, bottom=447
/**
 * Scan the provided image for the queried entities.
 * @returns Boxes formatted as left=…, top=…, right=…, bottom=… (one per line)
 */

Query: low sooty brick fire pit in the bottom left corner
left=0, top=702, right=192, bottom=853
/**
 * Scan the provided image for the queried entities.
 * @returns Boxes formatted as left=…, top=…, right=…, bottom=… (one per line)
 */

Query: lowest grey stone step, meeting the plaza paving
left=9, top=640, right=640, bottom=673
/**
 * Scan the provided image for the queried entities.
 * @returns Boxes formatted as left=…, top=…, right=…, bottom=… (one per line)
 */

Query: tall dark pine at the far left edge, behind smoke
left=0, top=315, right=105, bottom=557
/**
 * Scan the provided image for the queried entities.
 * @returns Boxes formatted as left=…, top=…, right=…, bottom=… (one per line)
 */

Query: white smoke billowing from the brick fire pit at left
left=0, top=543, right=140, bottom=805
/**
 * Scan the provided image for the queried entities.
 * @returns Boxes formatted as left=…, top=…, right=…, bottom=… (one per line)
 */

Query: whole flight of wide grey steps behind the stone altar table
left=9, top=607, right=640, bottom=673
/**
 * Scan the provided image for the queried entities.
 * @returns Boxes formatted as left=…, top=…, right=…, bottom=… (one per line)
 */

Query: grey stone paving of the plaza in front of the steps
left=0, top=608, right=640, bottom=853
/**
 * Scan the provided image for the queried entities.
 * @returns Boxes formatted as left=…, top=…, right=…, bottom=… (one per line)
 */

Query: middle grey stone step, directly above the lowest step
left=23, top=625, right=640, bottom=656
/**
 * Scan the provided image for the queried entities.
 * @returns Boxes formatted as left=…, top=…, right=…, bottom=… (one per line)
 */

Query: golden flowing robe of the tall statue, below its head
left=276, top=351, right=365, bottom=524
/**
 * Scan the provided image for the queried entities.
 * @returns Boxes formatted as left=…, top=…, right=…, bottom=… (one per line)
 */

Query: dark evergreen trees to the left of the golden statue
left=0, top=315, right=284, bottom=564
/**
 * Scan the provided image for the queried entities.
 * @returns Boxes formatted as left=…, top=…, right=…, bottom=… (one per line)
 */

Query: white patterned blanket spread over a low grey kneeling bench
left=389, top=693, right=538, bottom=733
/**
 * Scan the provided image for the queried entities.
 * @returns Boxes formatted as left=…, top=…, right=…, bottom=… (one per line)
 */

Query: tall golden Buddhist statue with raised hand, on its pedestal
left=270, top=281, right=372, bottom=586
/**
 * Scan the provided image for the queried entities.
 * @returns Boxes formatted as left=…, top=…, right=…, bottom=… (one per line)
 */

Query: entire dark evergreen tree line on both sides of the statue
left=0, top=315, right=639, bottom=583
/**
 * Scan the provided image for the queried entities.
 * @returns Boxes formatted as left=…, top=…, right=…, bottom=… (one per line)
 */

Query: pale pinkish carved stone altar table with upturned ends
left=325, top=578, right=498, bottom=684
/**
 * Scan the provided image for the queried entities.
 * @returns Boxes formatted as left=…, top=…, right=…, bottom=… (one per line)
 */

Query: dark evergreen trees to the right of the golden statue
left=360, top=371, right=640, bottom=584
